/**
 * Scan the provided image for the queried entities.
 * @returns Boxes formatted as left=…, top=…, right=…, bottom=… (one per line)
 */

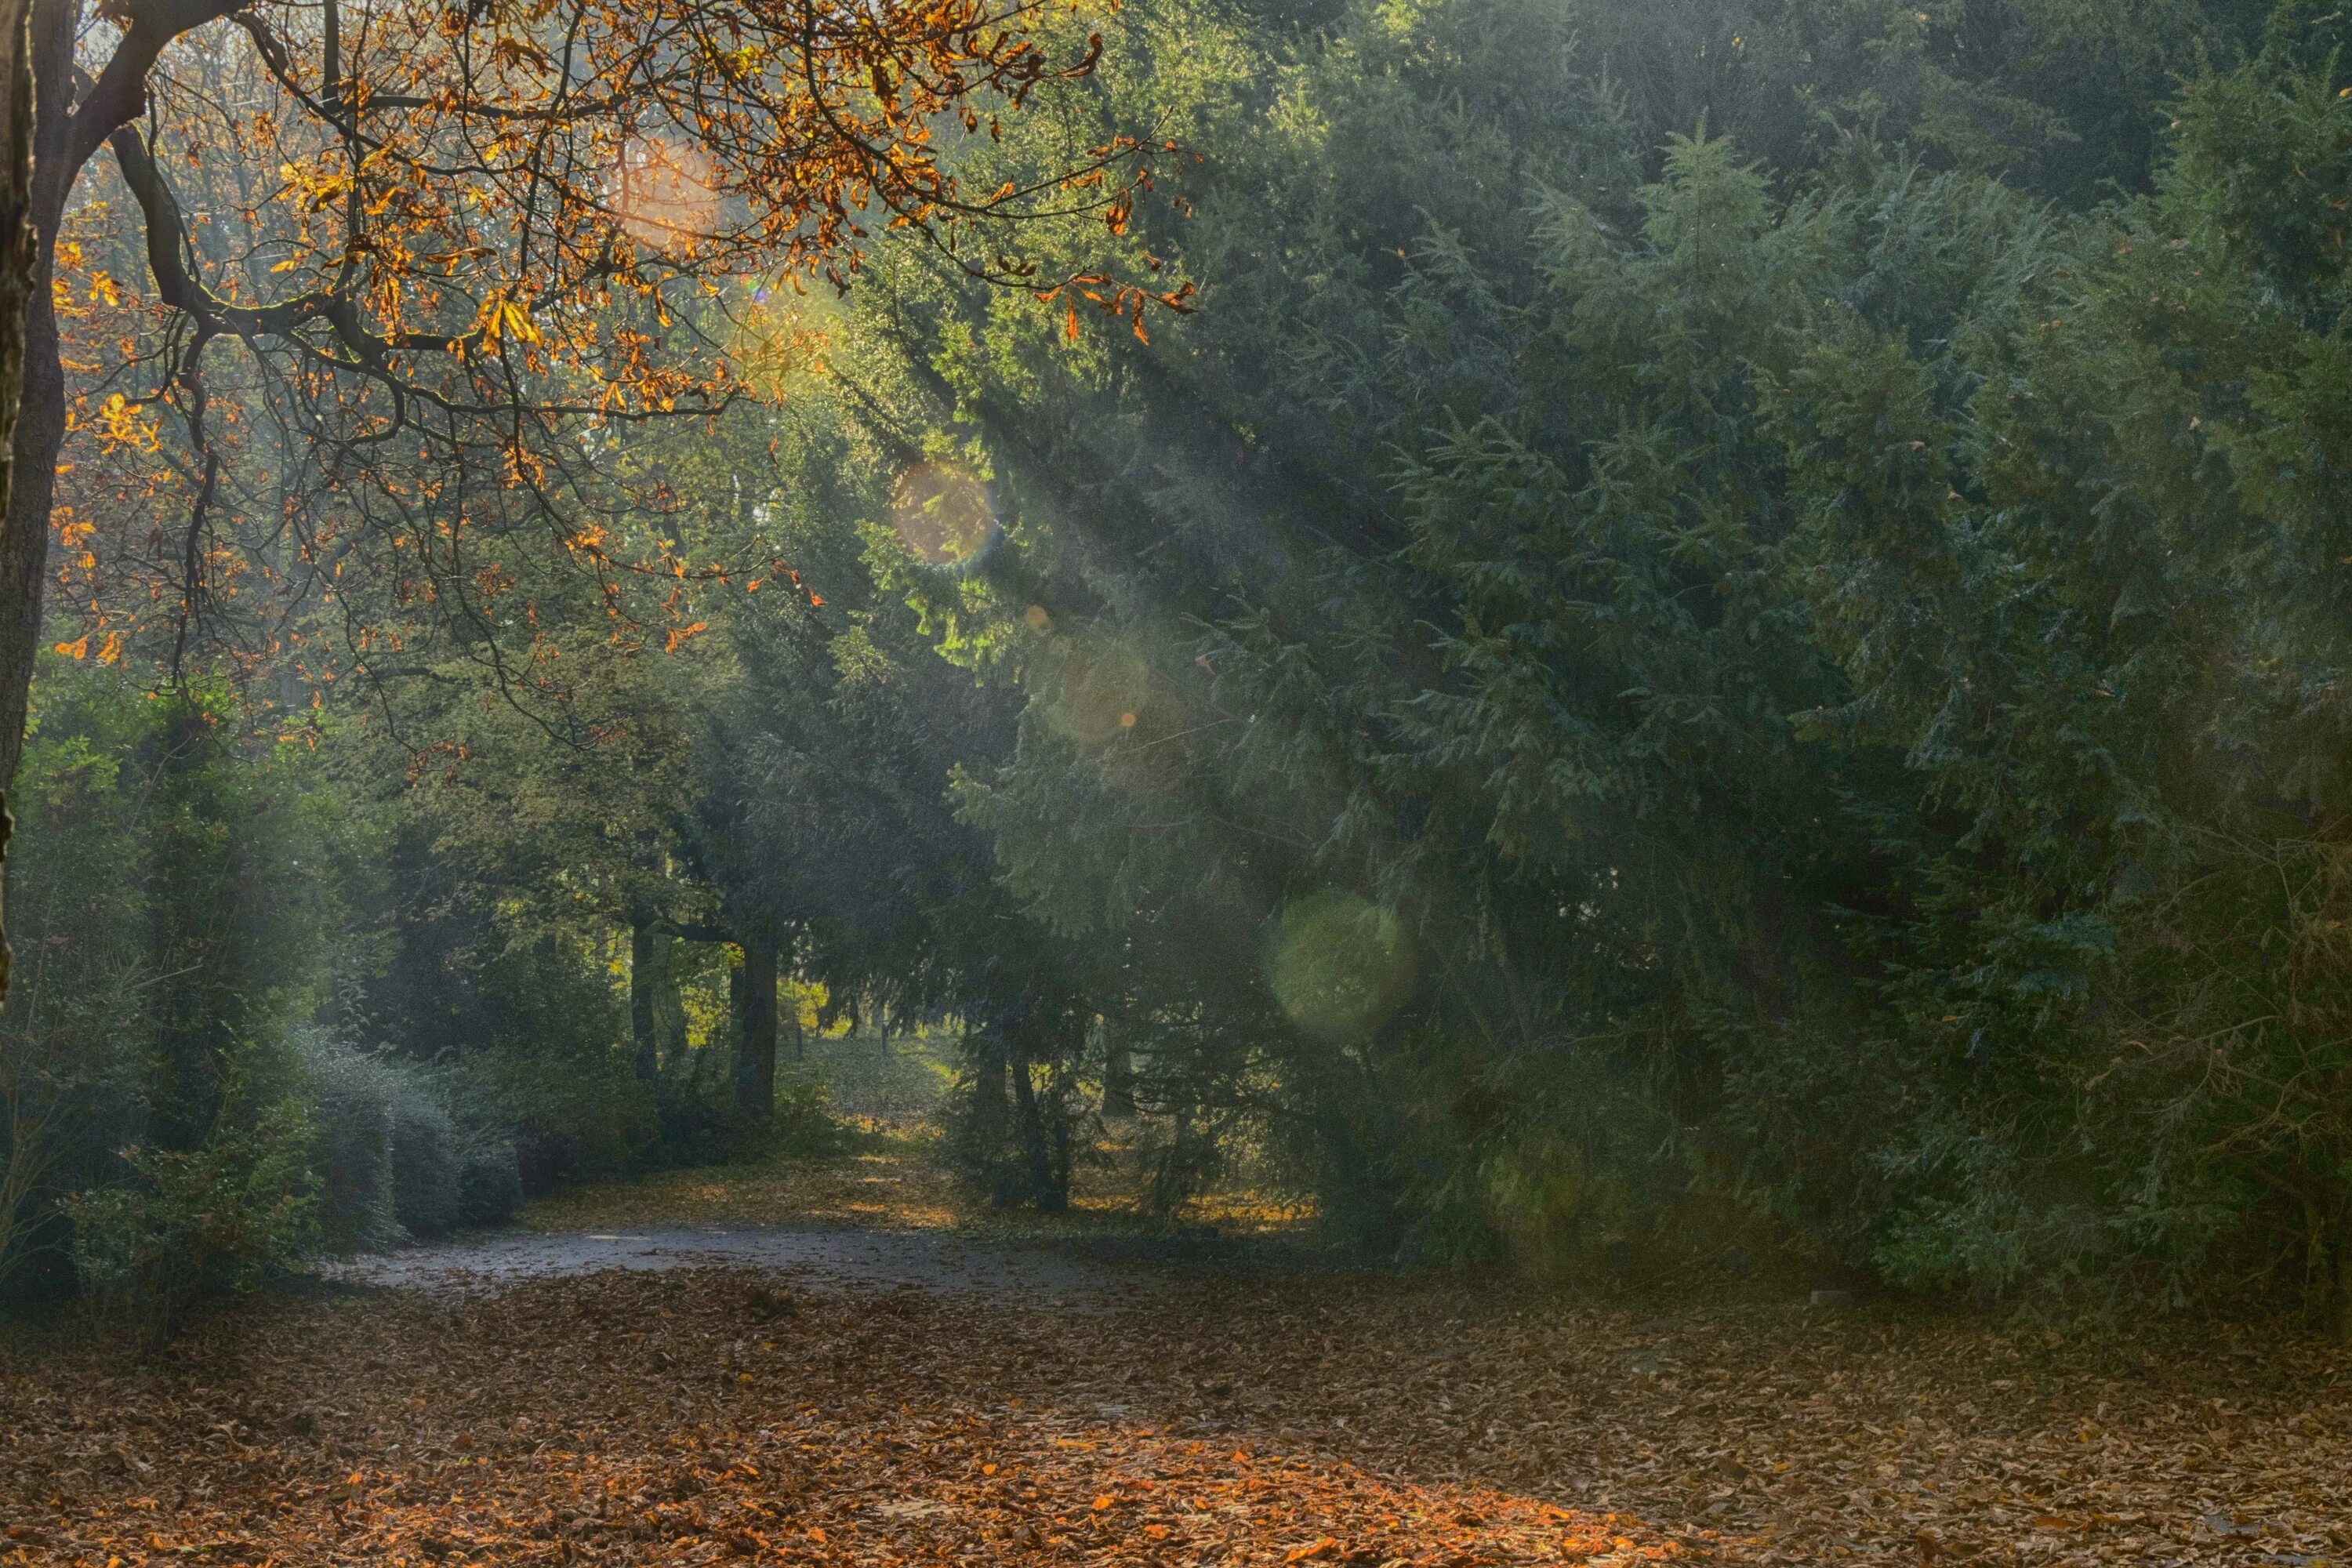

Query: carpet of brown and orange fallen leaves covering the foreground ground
left=0, top=1265, right=2352, bottom=1568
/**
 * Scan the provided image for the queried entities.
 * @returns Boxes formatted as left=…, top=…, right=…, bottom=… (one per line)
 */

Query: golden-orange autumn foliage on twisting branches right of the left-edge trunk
left=36, top=0, right=1185, bottom=691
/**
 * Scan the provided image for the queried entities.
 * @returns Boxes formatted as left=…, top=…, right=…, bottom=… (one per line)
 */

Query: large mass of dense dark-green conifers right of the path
left=833, top=0, right=2352, bottom=1305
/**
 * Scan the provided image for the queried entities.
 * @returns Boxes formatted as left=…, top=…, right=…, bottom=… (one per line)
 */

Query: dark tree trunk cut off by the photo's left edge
left=0, top=0, right=73, bottom=1020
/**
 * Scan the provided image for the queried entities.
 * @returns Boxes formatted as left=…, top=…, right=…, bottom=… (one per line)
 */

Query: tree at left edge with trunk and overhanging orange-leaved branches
left=0, top=0, right=1181, bottom=1006
